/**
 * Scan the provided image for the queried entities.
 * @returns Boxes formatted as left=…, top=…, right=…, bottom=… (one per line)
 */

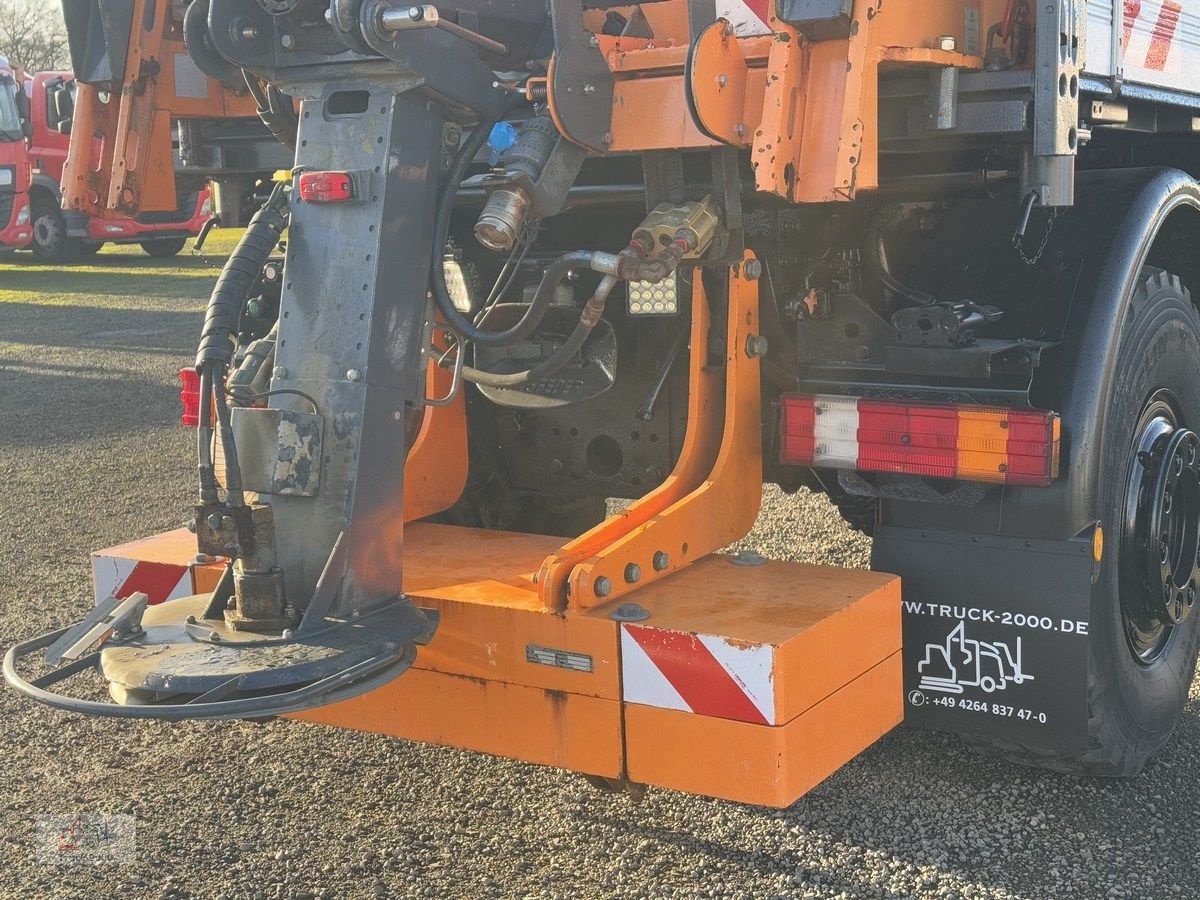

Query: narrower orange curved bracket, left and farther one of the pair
left=538, top=264, right=725, bottom=610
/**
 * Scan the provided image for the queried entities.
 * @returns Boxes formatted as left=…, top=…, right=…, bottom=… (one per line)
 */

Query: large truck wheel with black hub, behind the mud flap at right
left=970, top=266, right=1200, bottom=776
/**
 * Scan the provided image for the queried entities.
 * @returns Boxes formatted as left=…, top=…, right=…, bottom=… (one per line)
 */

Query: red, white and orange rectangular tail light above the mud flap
left=779, top=395, right=1061, bottom=487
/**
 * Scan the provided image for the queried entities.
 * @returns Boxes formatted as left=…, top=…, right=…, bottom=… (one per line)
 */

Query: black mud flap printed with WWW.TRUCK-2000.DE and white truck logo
left=871, top=526, right=1094, bottom=751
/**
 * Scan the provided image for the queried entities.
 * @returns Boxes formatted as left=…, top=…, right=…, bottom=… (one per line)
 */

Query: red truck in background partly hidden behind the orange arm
left=25, top=72, right=212, bottom=260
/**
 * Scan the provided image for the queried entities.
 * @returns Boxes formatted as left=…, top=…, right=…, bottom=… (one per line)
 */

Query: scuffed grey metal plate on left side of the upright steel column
left=232, top=408, right=322, bottom=497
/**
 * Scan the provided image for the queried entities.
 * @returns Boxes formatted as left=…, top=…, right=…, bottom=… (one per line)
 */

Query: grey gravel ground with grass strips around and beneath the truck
left=0, top=253, right=1200, bottom=898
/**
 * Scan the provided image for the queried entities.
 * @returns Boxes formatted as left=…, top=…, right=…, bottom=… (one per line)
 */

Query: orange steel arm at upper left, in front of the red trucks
left=62, top=0, right=257, bottom=218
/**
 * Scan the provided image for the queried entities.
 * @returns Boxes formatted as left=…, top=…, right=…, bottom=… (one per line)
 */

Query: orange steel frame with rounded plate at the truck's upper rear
left=566, top=0, right=1006, bottom=203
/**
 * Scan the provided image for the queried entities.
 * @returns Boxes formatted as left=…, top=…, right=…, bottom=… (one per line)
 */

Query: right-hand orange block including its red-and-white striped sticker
left=609, top=556, right=904, bottom=806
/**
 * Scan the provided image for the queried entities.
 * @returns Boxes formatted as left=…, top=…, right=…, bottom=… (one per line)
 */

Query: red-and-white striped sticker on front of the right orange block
left=620, top=625, right=775, bottom=725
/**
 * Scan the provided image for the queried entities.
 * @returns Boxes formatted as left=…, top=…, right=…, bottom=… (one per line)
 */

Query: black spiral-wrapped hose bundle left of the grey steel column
left=196, top=184, right=288, bottom=374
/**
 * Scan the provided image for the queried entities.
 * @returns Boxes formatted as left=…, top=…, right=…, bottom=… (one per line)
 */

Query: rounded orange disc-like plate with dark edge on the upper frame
left=688, top=19, right=769, bottom=148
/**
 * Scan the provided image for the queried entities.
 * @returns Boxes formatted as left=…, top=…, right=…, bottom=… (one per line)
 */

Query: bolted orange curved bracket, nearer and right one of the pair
left=569, top=253, right=762, bottom=610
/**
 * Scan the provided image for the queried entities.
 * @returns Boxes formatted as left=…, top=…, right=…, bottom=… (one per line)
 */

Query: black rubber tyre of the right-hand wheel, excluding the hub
left=971, top=266, right=1200, bottom=776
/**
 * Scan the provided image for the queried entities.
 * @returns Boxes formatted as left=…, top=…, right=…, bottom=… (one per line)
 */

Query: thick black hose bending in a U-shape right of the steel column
left=431, top=122, right=593, bottom=347
